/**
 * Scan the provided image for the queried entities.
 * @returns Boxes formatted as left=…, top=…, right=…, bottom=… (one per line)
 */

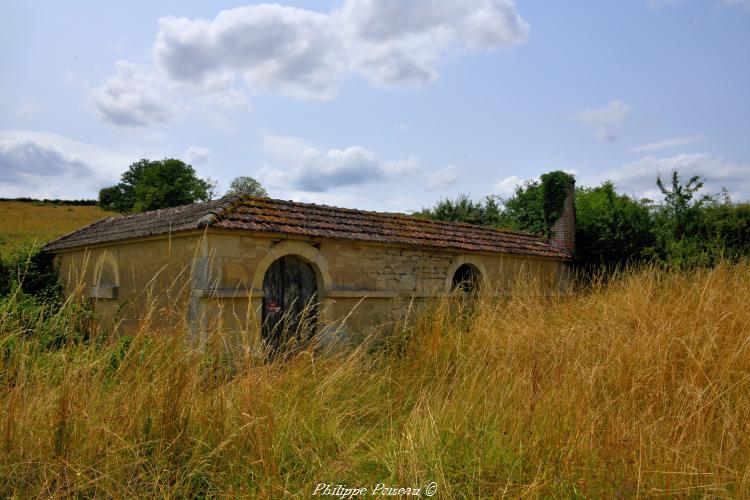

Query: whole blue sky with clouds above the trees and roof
left=0, top=0, right=750, bottom=211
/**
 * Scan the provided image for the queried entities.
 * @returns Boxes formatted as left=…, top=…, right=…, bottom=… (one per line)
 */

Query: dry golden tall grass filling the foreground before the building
left=0, top=265, right=750, bottom=498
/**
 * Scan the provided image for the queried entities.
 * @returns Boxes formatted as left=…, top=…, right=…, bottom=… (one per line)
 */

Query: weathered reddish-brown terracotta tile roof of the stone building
left=45, top=196, right=569, bottom=259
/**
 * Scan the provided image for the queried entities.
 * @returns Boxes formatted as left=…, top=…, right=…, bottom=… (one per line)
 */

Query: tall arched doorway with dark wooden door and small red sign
left=263, top=255, right=318, bottom=353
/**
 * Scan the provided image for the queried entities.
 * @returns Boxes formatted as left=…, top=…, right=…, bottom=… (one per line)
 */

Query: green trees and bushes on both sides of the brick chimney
left=416, top=170, right=750, bottom=270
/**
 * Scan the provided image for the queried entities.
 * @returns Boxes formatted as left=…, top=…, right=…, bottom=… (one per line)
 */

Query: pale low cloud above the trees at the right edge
left=595, top=153, right=750, bottom=201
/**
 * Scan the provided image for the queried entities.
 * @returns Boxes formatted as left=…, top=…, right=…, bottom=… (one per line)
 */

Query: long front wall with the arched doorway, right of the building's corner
left=203, top=233, right=568, bottom=331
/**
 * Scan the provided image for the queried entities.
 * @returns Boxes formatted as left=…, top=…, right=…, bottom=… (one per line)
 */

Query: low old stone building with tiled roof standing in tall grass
left=45, top=188, right=575, bottom=350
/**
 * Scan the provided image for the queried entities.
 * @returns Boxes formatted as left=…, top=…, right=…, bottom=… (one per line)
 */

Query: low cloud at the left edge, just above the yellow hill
left=0, top=130, right=128, bottom=198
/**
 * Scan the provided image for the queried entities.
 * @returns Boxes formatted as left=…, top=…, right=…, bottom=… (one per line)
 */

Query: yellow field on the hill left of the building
left=0, top=201, right=116, bottom=255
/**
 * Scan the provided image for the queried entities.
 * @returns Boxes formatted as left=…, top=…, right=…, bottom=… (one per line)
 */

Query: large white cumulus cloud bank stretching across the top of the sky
left=92, top=0, right=529, bottom=126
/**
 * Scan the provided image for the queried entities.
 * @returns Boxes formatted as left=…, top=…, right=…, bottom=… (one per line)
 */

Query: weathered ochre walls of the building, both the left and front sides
left=57, top=232, right=568, bottom=340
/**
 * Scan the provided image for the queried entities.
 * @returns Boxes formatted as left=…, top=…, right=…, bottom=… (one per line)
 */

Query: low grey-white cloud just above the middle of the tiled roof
left=259, top=137, right=418, bottom=193
